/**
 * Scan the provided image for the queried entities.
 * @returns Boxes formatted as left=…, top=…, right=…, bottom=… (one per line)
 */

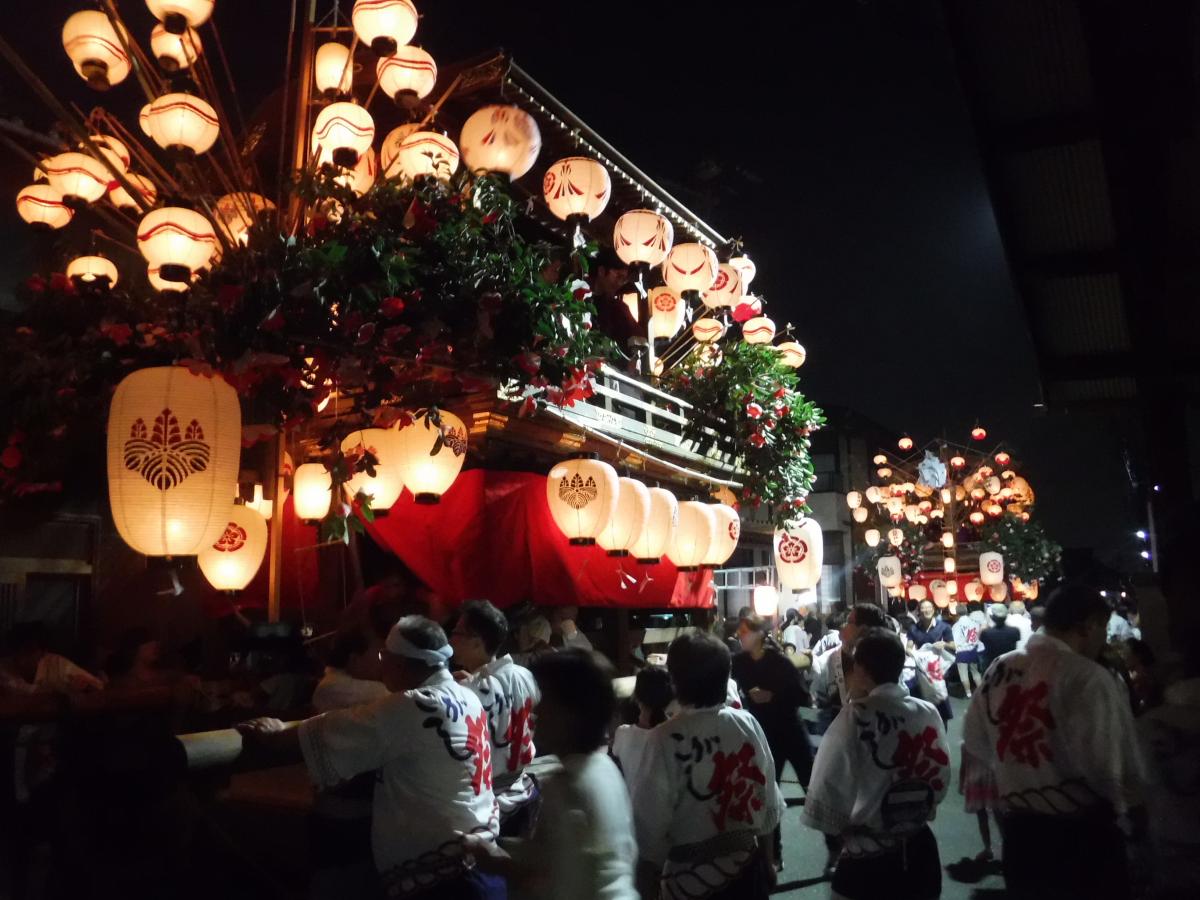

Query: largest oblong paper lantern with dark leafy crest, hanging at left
left=108, top=366, right=241, bottom=557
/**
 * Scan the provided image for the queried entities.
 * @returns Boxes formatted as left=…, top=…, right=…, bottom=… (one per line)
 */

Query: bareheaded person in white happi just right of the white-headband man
left=450, top=600, right=541, bottom=835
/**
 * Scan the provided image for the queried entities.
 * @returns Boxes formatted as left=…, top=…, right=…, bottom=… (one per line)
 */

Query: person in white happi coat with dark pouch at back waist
left=803, top=628, right=950, bottom=900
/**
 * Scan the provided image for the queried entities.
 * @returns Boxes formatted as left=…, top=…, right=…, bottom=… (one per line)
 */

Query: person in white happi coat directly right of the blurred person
left=632, top=634, right=790, bottom=900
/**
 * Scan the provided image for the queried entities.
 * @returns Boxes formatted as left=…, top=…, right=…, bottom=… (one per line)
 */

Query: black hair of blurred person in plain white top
left=532, top=647, right=617, bottom=752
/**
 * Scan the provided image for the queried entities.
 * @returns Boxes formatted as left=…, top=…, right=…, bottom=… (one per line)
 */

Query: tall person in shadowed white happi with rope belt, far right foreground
left=964, top=586, right=1144, bottom=899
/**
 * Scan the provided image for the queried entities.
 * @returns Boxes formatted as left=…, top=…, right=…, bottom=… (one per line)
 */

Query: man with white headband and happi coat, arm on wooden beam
left=240, top=616, right=504, bottom=900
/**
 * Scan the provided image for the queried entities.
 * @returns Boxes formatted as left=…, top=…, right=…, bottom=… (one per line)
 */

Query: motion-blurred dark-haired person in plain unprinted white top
left=466, top=648, right=637, bottom=900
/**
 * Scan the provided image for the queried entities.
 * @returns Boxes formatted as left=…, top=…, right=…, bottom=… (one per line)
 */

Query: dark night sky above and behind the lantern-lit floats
left=0, top=0, right=1138, bottom=571
